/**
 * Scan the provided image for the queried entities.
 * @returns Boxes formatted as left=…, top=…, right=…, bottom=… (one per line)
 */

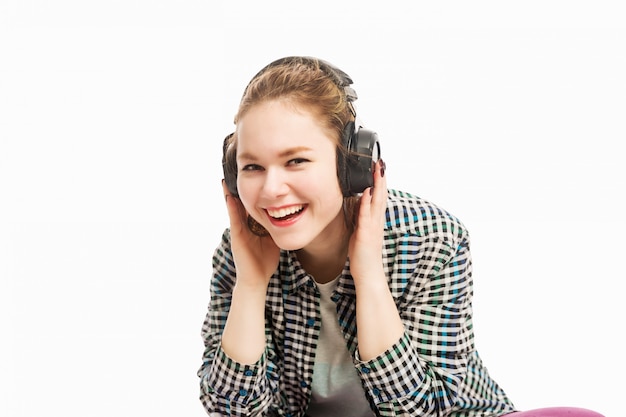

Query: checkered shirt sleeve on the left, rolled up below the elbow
left=198, top=231, right=271, bottom=416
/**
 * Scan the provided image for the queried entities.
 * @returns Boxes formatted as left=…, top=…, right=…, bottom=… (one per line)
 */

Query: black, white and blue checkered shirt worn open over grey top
left=198, top=190, right=514, bottom=417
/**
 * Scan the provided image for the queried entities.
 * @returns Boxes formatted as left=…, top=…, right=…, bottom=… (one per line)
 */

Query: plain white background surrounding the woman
left=0, top=0, right=626, bottom=417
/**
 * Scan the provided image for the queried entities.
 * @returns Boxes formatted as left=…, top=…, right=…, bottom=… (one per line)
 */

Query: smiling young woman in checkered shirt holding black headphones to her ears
left=198, top=57, right=599, bottom=417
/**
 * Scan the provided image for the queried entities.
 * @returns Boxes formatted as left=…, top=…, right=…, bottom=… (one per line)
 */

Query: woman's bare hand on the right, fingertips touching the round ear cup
left=348, top=160, right=387, bottom=285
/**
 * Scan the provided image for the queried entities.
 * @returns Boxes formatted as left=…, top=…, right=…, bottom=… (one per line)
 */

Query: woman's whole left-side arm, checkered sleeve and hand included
left=198, top=182, right=279, bottom=416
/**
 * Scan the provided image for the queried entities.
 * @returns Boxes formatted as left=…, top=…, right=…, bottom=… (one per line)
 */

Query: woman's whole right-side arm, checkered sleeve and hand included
left=349, top=164, right=473, bottom=416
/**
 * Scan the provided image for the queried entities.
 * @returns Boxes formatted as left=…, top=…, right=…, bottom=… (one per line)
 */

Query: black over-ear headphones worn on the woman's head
left=222, top=56, right=380, bottom=197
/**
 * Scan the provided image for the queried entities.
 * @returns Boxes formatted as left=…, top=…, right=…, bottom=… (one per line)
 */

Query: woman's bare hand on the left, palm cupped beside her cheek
left=222, top=180, right=280, bottom=287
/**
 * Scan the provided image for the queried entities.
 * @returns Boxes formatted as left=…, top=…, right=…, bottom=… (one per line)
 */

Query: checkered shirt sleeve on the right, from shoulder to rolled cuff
left=357, top=191, right=474, bottom=416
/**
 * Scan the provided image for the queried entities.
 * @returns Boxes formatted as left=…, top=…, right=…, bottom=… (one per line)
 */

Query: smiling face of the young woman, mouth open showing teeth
left=237, top=100, right=346, bottom=250
